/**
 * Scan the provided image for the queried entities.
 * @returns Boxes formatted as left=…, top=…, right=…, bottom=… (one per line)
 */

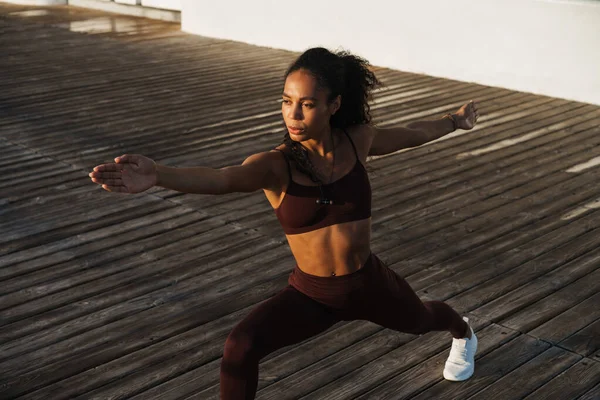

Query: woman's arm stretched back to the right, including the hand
left=369, top=100, right=479, bottom=156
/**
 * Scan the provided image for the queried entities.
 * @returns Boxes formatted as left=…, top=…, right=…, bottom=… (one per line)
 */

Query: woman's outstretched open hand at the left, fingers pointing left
left=89, top=154, right=158, bottom=193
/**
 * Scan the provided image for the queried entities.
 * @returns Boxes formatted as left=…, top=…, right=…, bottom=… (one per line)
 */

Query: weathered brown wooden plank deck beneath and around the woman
left=0, top=3, right=600, bottom=400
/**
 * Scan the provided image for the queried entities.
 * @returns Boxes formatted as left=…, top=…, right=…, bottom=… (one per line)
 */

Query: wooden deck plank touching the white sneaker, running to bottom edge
left=414, top=335, right=550, bottom=400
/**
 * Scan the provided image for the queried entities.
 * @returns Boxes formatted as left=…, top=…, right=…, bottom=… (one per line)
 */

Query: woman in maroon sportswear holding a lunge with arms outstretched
left=90, top=48, right=478, bottom=399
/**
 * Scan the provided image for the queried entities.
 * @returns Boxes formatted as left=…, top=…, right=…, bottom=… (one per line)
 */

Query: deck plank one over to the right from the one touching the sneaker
left=470, top=347, right=581, bottom=400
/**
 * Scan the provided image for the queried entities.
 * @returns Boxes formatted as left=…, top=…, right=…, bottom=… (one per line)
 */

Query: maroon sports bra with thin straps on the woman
left=275, top=131, right=371, bottom=235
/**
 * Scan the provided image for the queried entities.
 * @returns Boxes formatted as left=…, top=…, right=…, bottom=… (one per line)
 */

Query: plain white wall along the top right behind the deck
left=181, top=0, right=600, bottom=105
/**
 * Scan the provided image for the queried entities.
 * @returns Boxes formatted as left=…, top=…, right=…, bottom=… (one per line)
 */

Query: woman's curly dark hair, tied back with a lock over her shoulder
left=283, top=47, right=381, bottom=184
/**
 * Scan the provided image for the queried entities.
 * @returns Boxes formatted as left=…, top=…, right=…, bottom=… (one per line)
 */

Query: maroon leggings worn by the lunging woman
left=221, top=254, right=468, bottom=400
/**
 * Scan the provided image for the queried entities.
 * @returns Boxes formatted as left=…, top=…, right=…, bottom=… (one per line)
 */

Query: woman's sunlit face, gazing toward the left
left=281, top=69, right=341, bottom=142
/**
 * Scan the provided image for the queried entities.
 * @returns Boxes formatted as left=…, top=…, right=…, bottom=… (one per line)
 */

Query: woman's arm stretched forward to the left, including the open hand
left=89, top=152, right=283, bottom=194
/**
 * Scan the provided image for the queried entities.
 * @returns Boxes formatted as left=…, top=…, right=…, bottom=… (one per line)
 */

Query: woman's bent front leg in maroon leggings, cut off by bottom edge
left=221, top=286, right=338, bottom=400
